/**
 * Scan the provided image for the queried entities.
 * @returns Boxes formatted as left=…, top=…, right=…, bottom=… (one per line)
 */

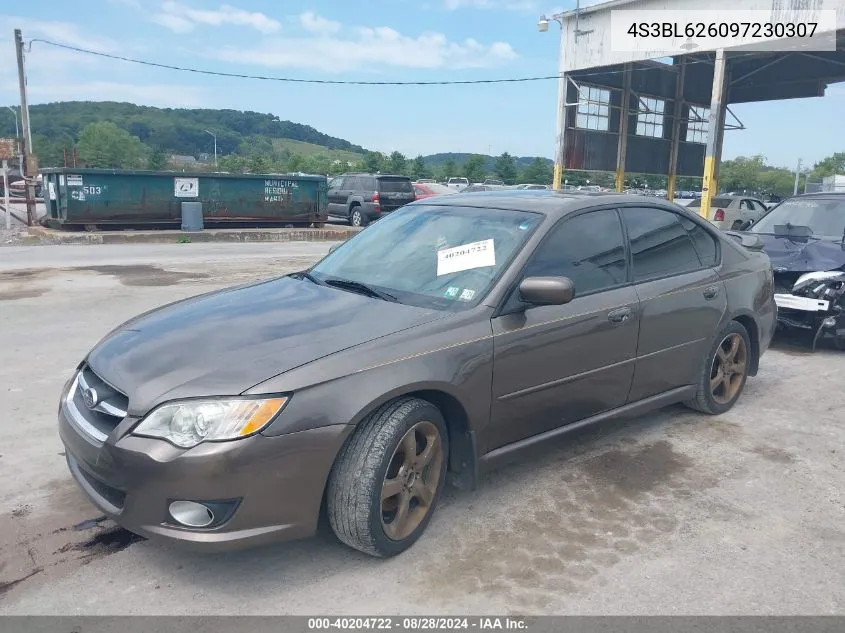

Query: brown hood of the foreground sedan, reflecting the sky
left=87, top=277, right=446, bottom=415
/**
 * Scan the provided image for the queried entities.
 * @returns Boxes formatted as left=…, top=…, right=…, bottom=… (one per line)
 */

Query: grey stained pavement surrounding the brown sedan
left=0, top=243, right=845, bottom=614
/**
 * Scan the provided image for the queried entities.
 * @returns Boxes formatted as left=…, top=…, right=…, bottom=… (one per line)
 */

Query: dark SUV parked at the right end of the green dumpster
left=329, top=174, right=416, bottom=226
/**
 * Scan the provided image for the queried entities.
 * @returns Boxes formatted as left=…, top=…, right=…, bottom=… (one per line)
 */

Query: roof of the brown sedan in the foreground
left=411, top=189, right=689, bottom=217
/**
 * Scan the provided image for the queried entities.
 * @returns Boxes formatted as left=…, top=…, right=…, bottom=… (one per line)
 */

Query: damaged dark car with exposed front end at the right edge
left=748, top=193, right=845, bottom=350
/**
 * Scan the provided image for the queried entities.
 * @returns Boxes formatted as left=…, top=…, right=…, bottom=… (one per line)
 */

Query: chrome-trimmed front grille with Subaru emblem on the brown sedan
left=66, top=365, right=129, bottom=443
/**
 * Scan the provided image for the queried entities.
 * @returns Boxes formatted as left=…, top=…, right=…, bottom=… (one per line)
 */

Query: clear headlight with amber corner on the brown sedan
left=132, top=397, right=288, bottom=448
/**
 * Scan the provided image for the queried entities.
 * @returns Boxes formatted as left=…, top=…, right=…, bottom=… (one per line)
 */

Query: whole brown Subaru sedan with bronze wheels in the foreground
left=59, top=191, right=776, bottom=556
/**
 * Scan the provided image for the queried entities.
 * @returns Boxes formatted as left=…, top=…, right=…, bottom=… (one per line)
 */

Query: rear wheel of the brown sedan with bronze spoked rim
left=684, top=321, right=751, bottom=415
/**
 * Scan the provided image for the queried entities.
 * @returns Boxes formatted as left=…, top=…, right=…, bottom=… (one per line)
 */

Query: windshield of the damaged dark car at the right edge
left=749, top=196, right=845, bottom=240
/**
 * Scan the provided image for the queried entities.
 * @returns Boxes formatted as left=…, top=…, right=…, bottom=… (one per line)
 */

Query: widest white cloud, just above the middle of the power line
left=210, top=21, right=517, bottom=72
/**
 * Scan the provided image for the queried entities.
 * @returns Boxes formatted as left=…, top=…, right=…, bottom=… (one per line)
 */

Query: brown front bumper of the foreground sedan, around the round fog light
left=59, top=378, right=351, bottom=551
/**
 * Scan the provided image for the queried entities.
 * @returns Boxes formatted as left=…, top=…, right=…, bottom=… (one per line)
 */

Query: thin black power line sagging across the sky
left=29, top=39, right=712, bottom=86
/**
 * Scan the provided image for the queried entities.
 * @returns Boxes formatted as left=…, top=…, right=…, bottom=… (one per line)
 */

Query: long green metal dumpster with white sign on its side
left=41, top=168, right=328, bottom=228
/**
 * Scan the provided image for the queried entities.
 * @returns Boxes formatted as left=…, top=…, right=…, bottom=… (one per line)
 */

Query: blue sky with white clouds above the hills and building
left=0, top=0, right=845, bottom=167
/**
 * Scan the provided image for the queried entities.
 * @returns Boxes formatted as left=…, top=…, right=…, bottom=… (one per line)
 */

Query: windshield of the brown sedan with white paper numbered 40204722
left=309, top=204, right=543, bottom=310
